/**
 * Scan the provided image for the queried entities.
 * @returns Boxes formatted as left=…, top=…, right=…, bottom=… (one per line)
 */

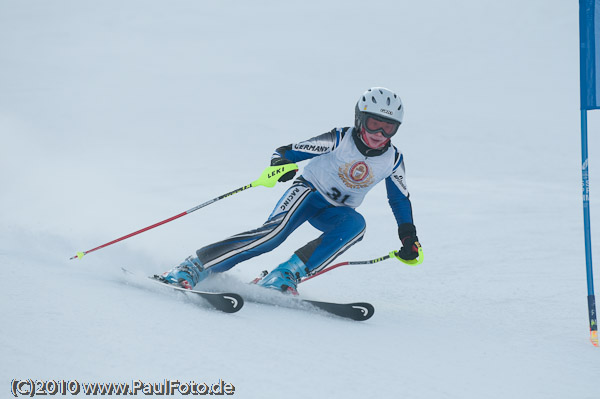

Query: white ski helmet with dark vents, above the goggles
left=354, top=87, right=404, bottom=133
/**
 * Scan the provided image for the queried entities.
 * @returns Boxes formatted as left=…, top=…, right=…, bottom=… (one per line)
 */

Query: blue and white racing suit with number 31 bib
left=196, top=127, right=413, bottom=274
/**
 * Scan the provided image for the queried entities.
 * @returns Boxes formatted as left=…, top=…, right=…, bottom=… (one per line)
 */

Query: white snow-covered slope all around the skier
left=0, top=0, right=600, bottom=399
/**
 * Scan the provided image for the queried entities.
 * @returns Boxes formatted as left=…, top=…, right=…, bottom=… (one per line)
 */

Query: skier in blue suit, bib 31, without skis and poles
left=157, top=87, right=420, bottom=294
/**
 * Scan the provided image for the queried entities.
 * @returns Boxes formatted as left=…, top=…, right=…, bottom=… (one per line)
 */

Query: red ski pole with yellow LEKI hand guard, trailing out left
left=69, top=163, right=298, bottom=260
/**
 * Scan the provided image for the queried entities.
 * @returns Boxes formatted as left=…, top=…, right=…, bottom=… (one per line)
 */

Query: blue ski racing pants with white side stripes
left=196, top=177, right=366, bottom=274
